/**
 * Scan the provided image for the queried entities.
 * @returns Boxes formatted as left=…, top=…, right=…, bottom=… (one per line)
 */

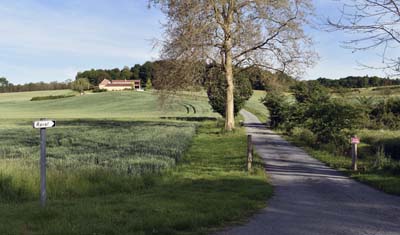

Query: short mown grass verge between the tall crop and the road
left=0, top=122, right=272, bottom=235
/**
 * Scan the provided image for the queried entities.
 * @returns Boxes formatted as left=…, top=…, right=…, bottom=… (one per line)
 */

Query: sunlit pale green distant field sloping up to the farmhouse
left=0, top=90, right=217, bottom=120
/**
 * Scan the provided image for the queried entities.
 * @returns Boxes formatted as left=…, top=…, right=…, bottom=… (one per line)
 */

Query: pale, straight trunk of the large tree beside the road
left=225, top=39, right=235, bottom=131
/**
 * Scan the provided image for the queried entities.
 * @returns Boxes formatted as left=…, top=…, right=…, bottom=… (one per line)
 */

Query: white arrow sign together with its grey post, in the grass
left=33, top=118, right=56, bottom=207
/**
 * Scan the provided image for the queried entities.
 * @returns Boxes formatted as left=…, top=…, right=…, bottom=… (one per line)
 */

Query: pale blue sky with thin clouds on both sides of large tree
left=0, top=0, right=396, bottom=84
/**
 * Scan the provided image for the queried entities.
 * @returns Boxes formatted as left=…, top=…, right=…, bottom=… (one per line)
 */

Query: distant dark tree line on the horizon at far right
left=316, top=76, right=400, bottom=88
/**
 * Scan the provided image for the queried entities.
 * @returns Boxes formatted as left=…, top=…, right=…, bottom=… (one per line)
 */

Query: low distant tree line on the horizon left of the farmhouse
left=0, top=77, right=71, bottom=93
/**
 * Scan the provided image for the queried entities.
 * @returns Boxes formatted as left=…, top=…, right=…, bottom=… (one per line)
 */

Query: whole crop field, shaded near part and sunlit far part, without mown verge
left=0, top=90, right=214, bottom=201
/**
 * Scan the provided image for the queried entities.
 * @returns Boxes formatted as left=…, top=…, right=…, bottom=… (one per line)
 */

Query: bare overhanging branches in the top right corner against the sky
left=328, top=0, right=400, bottom=75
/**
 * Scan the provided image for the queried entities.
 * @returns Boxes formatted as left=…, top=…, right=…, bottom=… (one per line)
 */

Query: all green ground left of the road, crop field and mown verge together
left=0, top=91, right=272, bottom=234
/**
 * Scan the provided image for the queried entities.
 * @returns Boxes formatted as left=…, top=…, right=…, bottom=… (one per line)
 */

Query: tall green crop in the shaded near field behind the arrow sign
left=0, top=120, right=195, bottom=201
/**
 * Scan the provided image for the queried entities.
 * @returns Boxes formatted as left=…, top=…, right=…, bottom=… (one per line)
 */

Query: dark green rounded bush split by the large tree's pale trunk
left=207, top=68, right=253, bottom=117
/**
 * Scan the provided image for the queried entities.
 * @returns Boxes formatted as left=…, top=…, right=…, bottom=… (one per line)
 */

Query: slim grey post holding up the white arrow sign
left=40, top=119, right=46, bottom=207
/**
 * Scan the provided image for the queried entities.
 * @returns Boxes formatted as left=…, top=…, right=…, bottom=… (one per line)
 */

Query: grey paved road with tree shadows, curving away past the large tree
left=220, top=111, right=400, bottom=235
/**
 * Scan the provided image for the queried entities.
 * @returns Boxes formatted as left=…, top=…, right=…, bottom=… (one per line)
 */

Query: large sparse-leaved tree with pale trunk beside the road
left=150, top=0, right=315, bottom=130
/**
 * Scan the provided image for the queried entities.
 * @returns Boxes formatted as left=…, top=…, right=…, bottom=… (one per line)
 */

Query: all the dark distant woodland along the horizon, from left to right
left=0, top=61, right=400, bottom=93
